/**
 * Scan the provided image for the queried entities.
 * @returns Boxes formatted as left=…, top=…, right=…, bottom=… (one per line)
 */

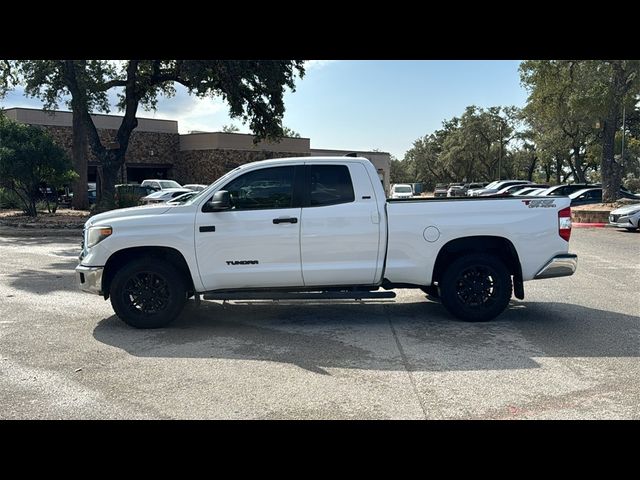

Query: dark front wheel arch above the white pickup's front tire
left=102, top=246, right=195, bottom=300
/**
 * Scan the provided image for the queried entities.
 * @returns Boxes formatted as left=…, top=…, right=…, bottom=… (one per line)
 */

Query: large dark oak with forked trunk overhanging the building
left=0, top=60, right=304, bottom=210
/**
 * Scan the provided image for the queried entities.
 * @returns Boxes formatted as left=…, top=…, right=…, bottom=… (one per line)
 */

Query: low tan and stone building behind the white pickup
left=4, top=108, right=391, bottom=192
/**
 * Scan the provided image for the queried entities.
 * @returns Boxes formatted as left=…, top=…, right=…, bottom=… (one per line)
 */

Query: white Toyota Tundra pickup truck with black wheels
left=76, top=157, right=577, bottom=328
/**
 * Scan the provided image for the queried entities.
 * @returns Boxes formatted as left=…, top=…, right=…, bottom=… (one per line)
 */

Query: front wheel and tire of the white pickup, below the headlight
left=109, top=257, right=187, bottom=328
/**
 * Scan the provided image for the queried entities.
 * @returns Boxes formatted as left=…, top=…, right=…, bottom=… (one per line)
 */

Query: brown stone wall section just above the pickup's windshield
left=174, top=149, right=309, bottom=185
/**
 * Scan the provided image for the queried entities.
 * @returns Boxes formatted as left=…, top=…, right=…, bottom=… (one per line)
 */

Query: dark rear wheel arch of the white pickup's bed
left=431, top=235, right=524, bottom=299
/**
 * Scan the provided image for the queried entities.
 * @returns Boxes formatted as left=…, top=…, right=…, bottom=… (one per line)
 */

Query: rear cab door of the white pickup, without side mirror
left=301, top=163, right=382, bottom=286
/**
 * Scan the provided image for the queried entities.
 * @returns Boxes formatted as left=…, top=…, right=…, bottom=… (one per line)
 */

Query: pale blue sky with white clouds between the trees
left=0, top=60, right=527, bottom=158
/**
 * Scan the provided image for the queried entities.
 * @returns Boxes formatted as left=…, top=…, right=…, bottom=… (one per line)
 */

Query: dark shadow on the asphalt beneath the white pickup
left=94, top=301, right=640, bottom=374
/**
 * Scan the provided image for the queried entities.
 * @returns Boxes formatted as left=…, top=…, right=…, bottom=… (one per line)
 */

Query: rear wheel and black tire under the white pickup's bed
left=439, top=254, right=512, bottom=322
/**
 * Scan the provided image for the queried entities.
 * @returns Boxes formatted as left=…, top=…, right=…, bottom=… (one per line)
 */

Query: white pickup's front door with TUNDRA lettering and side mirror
left=195, top=165, right=304, bottom=290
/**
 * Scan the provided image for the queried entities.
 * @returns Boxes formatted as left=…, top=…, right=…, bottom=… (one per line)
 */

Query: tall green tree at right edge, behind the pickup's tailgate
left=520, top=60, right=640, bottom=202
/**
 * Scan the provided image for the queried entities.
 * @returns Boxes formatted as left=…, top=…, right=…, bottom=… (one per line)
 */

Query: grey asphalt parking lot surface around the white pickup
left=0, top=228, right=640, bottom=419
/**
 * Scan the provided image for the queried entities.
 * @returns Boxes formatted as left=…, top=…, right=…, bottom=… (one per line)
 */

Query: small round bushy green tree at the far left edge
left=0, top=115, right=75, bottom=217
